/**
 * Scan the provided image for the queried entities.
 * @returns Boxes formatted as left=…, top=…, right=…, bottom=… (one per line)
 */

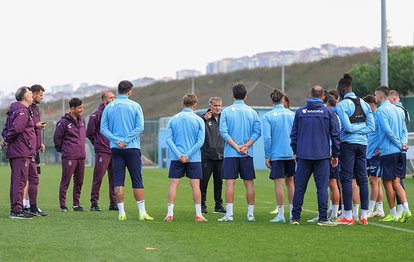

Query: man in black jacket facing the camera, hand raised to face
left=200, top=97, right=226, bottom=214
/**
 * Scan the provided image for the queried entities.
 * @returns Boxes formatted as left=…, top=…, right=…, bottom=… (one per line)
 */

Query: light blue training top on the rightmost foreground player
left=376, top=100, right=407, bottom=156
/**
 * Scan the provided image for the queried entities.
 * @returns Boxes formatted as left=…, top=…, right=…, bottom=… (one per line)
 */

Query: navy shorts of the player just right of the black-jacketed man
left=221, top=156, right=256, bottom=180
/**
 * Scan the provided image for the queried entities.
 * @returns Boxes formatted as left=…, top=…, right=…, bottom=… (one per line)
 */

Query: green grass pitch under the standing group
left=0, top=166, right=414, bottom=261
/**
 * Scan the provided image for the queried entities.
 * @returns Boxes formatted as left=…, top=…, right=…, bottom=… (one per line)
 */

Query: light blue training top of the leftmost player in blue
left=101, top=95, right=144, bottom=149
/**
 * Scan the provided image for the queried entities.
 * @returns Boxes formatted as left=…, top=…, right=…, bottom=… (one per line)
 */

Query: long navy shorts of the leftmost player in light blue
left=111, top=148, right=144, bottom=188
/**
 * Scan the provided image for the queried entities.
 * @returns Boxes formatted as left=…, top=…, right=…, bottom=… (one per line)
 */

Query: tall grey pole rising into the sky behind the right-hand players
left=381, top=0, right=388, bottom=86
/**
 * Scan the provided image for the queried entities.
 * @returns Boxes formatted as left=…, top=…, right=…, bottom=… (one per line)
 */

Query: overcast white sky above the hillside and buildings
left=0, top=0, right=414, bottom=92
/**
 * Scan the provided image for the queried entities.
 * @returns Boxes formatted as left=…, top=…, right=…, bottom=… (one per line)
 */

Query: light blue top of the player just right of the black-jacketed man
left=220, top=100, right=261, bottom=157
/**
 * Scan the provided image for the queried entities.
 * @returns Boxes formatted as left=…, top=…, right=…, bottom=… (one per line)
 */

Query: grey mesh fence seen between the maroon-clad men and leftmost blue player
left=0, top=119, right=158, bottom=166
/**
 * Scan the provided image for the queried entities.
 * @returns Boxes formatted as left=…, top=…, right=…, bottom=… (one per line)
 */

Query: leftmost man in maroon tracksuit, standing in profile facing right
left=2, top=86, right=36, bottom=219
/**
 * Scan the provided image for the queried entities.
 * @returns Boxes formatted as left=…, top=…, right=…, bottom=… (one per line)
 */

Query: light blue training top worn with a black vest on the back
left=335, top=92, right=375, bottom=145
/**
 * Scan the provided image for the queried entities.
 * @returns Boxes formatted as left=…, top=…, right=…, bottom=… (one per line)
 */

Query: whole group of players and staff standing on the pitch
left=2, top=74, right=412, bottom=226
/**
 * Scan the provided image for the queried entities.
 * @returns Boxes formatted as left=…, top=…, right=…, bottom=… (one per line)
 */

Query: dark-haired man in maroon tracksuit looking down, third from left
left=53, top=98, right=86, bottom=212
